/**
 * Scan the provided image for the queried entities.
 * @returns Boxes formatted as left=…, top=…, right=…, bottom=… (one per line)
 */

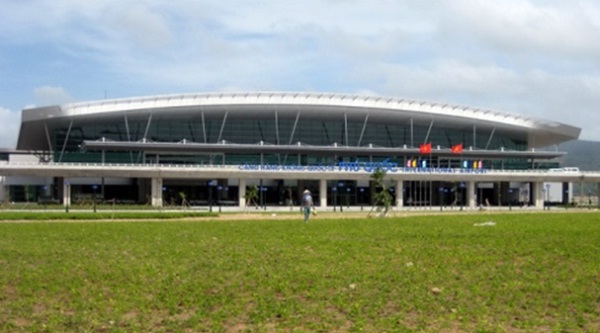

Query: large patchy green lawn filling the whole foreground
left=0, top=213, right=600, bottom=332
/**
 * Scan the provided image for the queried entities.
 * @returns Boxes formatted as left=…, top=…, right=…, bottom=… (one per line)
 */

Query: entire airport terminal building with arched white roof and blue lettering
left=0, top=92, right=583, bottom=208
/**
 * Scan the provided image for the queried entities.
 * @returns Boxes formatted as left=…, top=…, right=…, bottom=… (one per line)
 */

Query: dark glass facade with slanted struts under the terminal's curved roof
left=51, top=110, right=531, bottom=169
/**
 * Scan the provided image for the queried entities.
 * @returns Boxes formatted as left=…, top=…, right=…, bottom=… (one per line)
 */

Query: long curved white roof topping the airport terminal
left=19, top=92, right=581, bottom=147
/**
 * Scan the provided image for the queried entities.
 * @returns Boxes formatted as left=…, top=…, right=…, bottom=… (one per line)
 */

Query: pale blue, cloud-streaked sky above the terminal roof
left=0, top=0, right=600, bottom=148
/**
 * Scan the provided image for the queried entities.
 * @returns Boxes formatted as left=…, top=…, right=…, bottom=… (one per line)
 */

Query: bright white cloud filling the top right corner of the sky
left=442, top=0, right=600, bottom=61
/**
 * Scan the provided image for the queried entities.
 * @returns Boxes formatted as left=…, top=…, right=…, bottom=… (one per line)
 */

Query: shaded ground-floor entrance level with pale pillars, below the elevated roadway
left=4, top=177, right=580, bottom=210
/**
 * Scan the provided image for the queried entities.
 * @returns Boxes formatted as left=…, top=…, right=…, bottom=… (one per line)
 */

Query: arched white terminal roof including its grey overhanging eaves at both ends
left=17, top=92, right=581, bottom=150
